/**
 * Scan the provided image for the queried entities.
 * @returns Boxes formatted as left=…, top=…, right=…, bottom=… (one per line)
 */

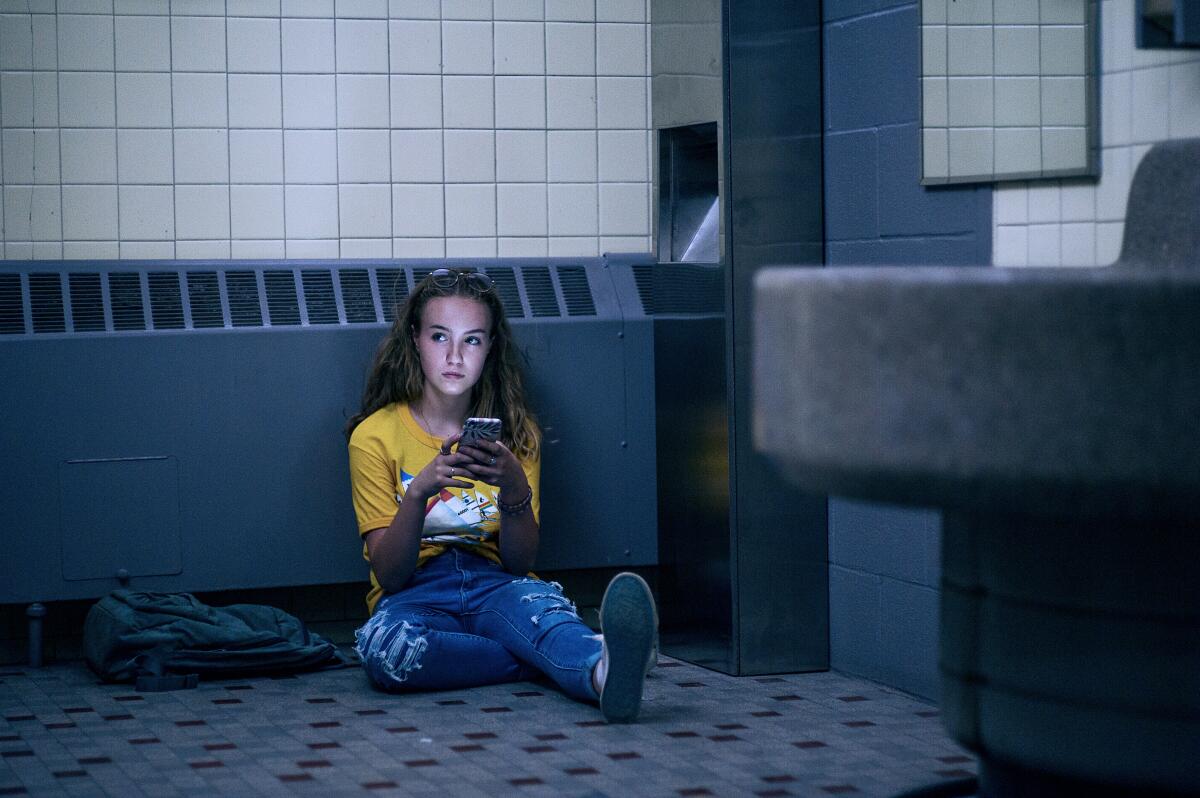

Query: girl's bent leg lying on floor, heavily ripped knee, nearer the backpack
left=355, top=594, right=536, bottom=691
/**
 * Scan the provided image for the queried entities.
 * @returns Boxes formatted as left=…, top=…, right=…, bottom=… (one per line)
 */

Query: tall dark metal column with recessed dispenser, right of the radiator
left=647, top=0, right=828, bottom=674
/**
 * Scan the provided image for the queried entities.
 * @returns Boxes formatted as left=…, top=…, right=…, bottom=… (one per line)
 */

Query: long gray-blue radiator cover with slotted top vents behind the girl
left=0, top=257, right=658, bottom=604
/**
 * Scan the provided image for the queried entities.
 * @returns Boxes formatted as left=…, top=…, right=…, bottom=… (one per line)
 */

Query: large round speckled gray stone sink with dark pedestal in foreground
left=755, top=140, right=1200, bottom=796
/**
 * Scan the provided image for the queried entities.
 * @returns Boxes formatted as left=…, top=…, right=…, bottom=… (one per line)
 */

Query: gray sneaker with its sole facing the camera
left=600, top=571, right=659, bottom=724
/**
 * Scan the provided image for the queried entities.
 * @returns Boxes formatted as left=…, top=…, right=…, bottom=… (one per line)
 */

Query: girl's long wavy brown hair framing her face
left=346, top=268, right=541, bottom=460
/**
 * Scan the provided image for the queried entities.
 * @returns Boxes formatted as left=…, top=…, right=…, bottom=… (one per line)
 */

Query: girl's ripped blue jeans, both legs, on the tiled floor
left=355, top=548, right=601, bottom=702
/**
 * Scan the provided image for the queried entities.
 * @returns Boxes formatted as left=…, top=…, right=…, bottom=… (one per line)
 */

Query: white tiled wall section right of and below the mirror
left=992, top=0, right=1200, bottom=266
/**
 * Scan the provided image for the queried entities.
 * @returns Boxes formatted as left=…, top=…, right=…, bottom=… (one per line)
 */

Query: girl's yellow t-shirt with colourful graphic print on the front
left=349, top=403, right=541, bottom=612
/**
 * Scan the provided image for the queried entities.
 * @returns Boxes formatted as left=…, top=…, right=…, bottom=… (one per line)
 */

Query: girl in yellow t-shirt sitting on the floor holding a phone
left=347, top=269, right=656, bottom=722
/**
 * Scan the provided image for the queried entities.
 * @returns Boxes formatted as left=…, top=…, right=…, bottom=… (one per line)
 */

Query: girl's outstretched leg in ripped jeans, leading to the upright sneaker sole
left=463, top=568, right=601, bottom=702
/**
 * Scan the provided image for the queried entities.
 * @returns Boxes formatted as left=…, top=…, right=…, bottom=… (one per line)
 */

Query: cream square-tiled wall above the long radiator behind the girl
left=0, top=0, right=652, bottom=258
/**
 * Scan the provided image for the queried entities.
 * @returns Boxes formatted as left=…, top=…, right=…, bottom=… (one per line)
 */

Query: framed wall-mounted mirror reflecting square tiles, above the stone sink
left=920, top=0, right=1099, bottom=185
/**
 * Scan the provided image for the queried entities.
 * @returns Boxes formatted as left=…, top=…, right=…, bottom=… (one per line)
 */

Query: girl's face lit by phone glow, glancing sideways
left=413, top=296, right=492, bottom=398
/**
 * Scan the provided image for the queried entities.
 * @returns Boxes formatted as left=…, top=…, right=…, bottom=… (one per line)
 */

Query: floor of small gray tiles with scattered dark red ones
left=0, top=658, right=976, bottom=797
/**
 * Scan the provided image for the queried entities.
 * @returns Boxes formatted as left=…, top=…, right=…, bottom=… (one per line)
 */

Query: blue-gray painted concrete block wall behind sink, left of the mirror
left=823, top=0, right=992, bottom=698
